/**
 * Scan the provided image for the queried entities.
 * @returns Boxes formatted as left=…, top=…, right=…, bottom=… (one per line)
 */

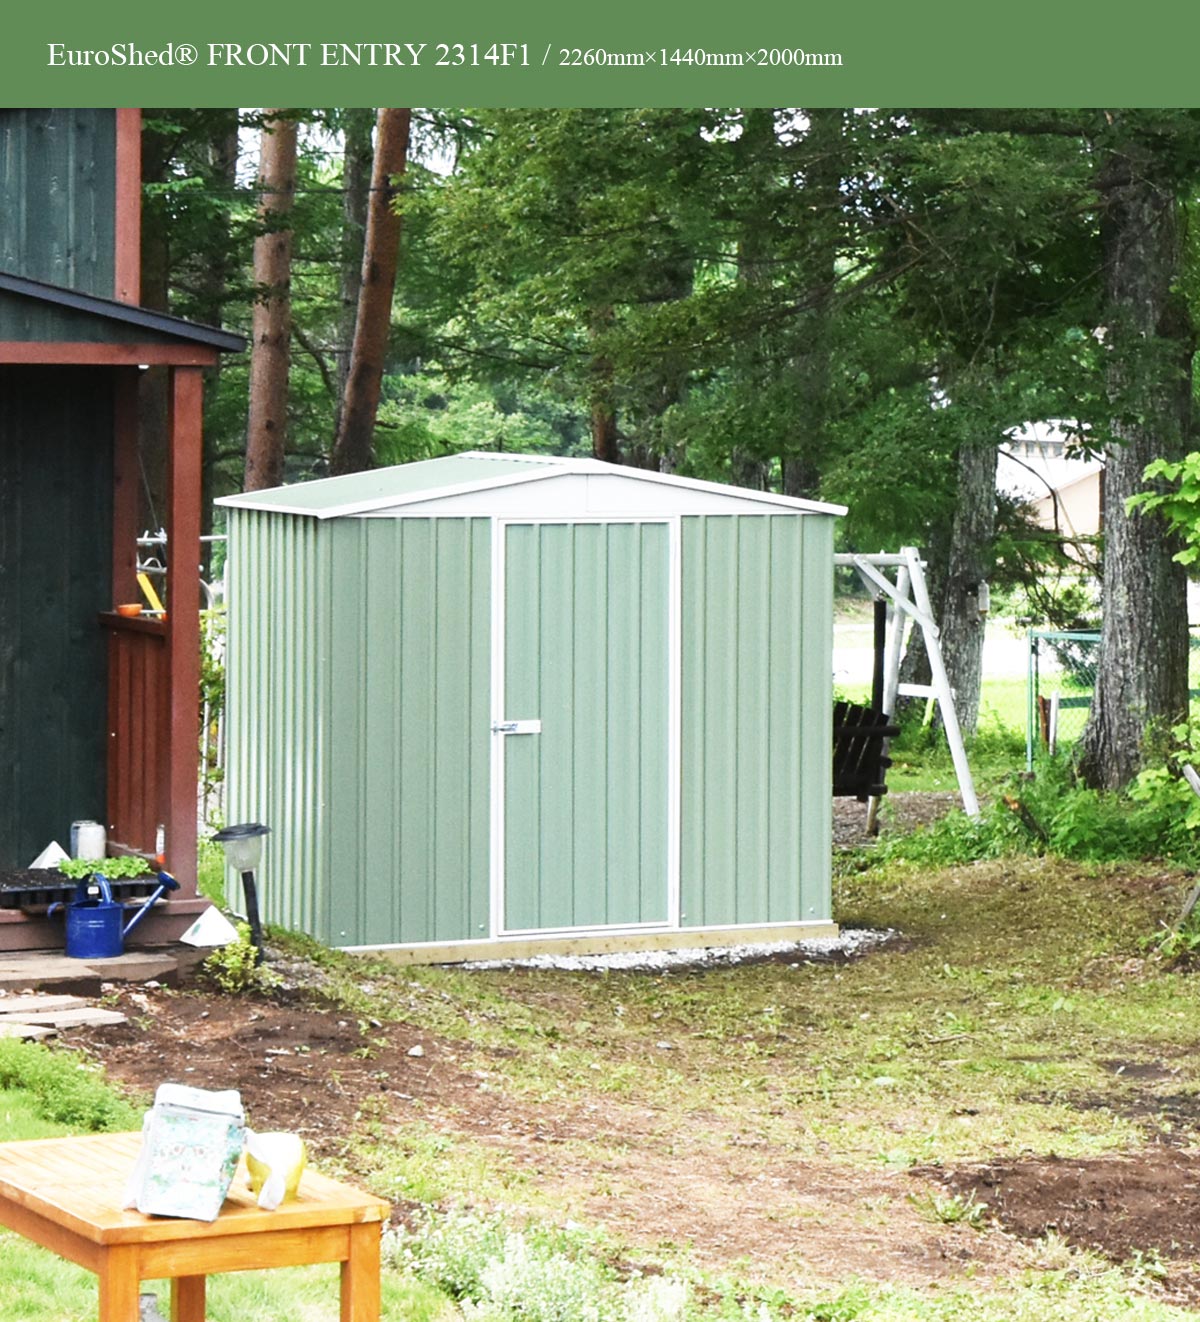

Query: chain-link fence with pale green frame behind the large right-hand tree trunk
left=1026, top=629, right=1200, bottom=771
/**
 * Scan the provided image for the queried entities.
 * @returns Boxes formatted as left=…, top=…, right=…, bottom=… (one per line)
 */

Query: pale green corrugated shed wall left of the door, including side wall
left=229, top=510, right=490, bottom=945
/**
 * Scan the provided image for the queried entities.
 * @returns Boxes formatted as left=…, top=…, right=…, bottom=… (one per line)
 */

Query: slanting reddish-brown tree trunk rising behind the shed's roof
left=329, top=110, right=412, bottom=475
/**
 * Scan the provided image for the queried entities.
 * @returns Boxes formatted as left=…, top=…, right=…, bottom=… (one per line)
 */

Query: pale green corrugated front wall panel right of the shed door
left=679, top=516, right=833, bottom=927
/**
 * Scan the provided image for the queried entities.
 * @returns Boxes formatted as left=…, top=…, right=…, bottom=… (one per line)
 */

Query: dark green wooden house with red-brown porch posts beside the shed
left=0, top=110, right=243, bottom=949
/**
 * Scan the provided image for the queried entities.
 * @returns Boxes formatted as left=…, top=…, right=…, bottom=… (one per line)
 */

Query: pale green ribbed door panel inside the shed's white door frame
left=502, top=522, right=670, bottom=931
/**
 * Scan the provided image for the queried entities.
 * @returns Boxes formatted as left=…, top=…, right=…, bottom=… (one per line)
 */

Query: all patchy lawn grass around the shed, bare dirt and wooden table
left=7, top=854, right=1200, bottom=1322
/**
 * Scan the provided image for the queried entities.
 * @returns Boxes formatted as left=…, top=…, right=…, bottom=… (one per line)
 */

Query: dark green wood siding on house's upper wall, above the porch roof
left=0, top=110, right=116, bottom=299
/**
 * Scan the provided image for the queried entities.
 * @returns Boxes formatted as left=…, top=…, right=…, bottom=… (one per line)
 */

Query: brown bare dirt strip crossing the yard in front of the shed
left=63, top=795, right=1200, bottom=1301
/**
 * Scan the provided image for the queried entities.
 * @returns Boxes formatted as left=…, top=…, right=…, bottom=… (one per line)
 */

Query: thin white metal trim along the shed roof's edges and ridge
left=214, top=449, right=847, bottom=520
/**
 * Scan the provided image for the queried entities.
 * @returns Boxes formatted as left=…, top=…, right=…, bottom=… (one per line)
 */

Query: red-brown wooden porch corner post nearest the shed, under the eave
left=165, top=368, right=204, bottom=895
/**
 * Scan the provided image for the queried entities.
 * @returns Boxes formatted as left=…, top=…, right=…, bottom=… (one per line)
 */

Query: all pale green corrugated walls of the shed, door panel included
left=229, top=499, right=833, bottom=945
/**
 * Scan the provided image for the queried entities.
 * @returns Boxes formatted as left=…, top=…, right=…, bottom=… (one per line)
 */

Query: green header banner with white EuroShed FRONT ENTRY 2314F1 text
left=7, top=0, right=1200, bottom=106
